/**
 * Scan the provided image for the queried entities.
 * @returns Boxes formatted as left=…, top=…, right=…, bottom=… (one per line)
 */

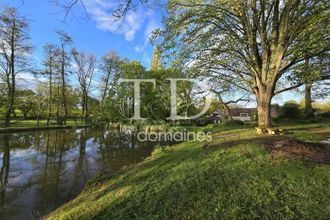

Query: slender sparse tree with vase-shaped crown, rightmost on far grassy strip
left=72, top=49, right=96, bottom=123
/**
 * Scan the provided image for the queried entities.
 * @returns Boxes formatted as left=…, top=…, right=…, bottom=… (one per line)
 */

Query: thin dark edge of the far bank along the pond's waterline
left=0, top=124, right=91, bottom=134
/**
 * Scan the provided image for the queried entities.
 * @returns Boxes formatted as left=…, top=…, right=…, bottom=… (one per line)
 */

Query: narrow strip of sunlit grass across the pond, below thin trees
left=0, top=120, right=88, bottom=134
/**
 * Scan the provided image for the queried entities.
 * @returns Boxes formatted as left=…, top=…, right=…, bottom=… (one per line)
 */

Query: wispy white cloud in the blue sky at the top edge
left=84, top=0, right=147, bottom=41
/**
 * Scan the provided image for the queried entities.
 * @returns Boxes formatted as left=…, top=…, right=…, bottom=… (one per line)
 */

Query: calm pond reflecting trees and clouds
left=0, top=129, right=167, bottom=219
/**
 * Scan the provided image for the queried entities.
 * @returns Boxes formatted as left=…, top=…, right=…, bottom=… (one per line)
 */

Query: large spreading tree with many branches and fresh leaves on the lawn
left=163, top=0, right=330, bottom=129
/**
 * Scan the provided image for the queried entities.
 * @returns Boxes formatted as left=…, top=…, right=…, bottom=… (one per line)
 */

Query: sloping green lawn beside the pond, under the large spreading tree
left=46, top=124, right=330, bottom=219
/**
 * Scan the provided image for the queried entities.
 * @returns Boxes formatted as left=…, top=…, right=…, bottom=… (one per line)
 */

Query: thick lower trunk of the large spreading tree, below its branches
left=257, top=92, right=272, bottom=129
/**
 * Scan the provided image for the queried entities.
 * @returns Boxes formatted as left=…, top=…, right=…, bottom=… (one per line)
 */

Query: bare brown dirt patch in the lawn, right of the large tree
left=260, top=138, right=330, bottom=164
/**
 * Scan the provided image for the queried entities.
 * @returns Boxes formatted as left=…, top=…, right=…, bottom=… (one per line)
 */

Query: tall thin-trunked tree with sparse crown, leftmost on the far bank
left=0, top=7, right=31, bottom=127
